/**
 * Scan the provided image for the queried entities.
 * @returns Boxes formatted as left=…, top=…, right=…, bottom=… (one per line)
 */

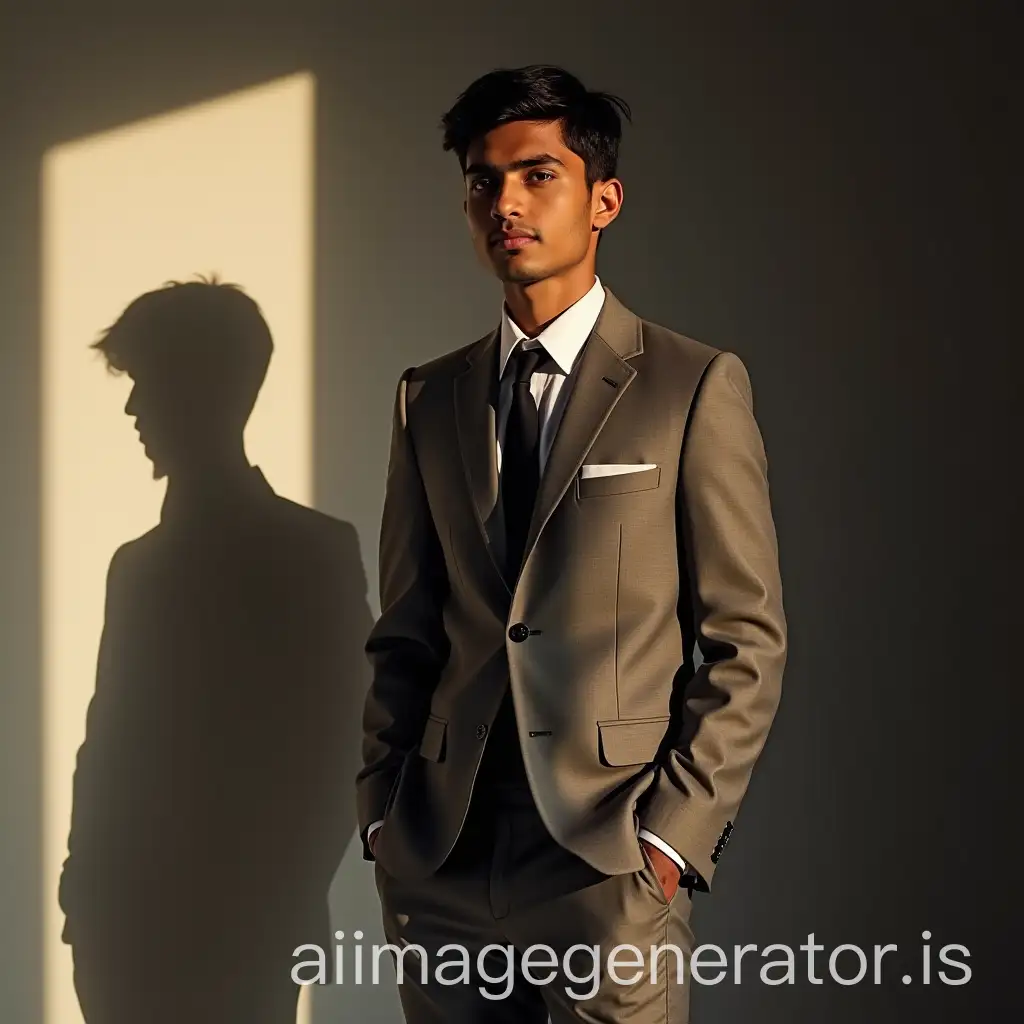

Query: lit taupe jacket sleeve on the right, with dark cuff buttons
left=637, top=352, right=786, bottom=891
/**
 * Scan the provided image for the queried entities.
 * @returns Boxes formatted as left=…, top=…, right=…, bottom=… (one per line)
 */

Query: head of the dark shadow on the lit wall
left=91, top=275, right=273, bottom=478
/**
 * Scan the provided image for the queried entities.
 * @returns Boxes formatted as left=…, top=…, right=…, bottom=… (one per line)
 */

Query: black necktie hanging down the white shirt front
left=501, top=347, right=558, bottom=581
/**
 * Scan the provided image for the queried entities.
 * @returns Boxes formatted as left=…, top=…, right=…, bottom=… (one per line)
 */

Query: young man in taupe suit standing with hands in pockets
left=356, top=66, right=786, bottom=1024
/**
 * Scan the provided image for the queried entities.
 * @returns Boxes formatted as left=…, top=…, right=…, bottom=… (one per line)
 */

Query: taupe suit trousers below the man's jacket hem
left=375, top=782, right=693, bottom=1024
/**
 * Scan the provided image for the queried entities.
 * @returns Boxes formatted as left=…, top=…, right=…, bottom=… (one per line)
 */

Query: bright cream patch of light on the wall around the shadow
left=42, top=74, right=314, bottom=1024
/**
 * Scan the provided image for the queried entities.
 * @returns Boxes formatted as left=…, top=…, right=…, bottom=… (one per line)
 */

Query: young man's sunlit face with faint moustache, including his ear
left=464, top=121, right=616, bottom=284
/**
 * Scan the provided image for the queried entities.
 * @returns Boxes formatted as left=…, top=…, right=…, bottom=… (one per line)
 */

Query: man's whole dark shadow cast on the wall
left=51, top=281, right=372, bottom=1024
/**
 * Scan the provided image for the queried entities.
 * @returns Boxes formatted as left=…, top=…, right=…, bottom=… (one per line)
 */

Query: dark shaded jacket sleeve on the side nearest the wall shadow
left=355, top=368, right=451, bottom=860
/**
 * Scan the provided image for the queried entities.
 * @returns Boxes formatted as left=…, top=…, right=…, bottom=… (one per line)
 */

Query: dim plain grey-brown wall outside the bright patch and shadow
left=0, top=0, right=1021, bottom=1024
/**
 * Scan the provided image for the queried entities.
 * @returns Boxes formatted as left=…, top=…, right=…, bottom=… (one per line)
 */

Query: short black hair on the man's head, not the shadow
left=441, top=65, right=632, bottom=188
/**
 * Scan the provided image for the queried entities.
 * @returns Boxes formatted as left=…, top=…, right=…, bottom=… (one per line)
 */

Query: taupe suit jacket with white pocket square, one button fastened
left=356, top=289, right=786, bottom=890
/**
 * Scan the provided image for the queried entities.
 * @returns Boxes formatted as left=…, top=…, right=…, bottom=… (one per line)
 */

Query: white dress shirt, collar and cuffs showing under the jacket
left=367, top=275, right=687, bottom=872
